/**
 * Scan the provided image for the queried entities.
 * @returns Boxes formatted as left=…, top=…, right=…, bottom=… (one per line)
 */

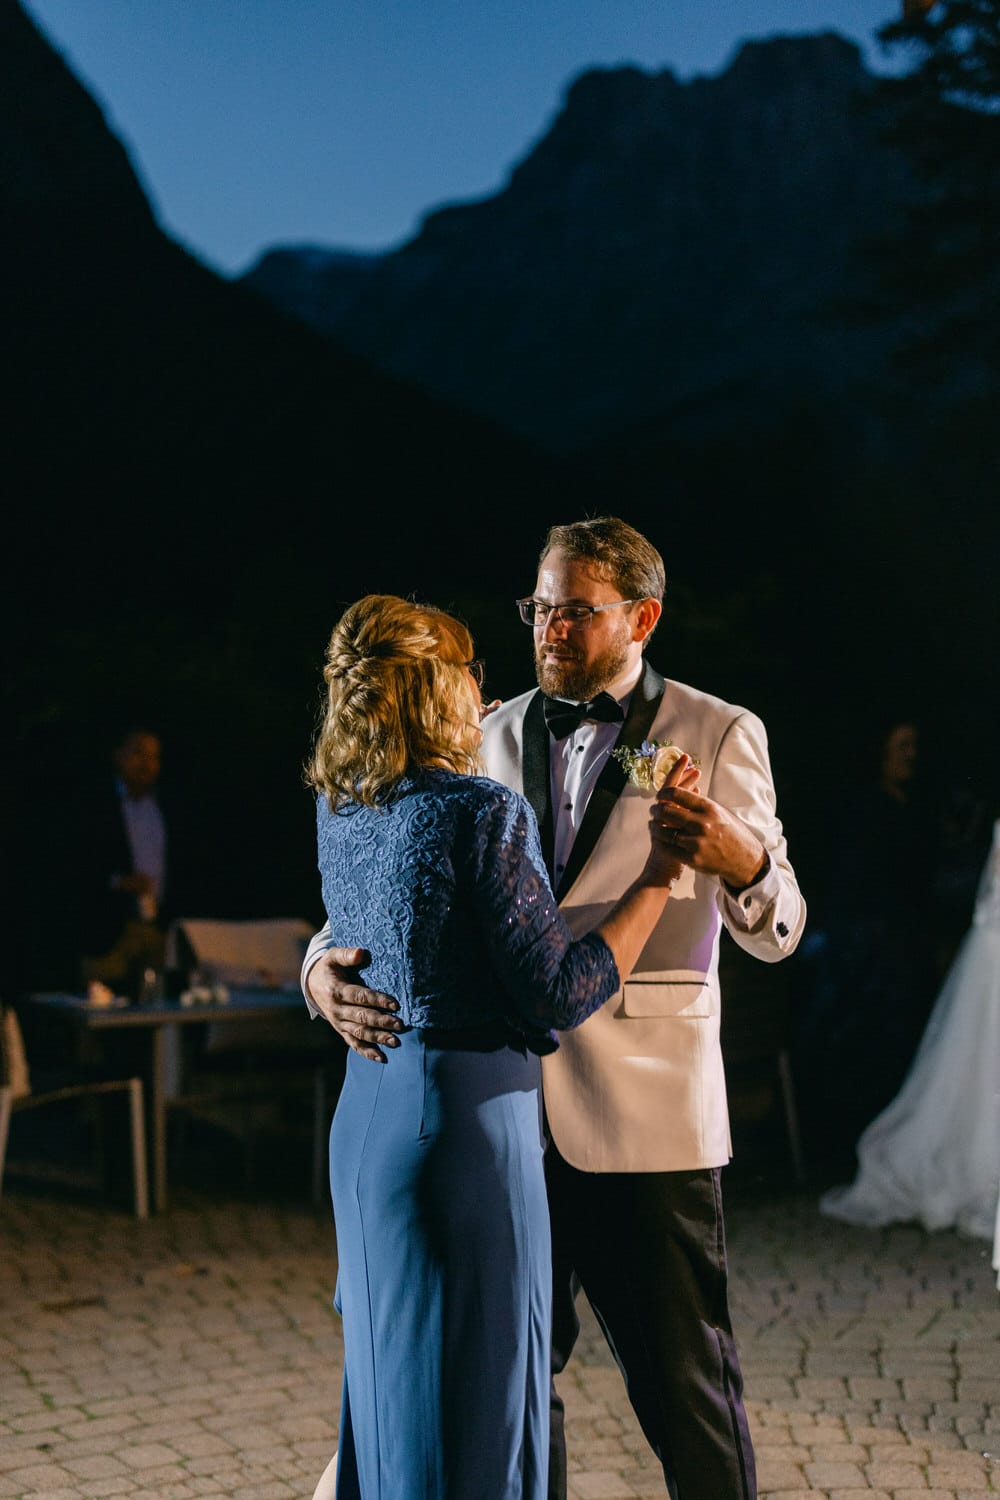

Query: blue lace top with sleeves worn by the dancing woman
left=316, top=771, right=619, bottom=1052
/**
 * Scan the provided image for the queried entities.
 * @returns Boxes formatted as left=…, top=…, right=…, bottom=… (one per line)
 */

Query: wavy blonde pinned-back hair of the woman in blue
left=306, top=594, right=483, bottom=812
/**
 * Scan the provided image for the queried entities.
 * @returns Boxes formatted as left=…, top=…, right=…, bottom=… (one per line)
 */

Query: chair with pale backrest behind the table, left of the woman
left=166, top=918, right=342, bottom=1208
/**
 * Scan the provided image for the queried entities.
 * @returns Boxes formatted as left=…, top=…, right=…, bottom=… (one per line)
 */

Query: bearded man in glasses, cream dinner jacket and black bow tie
left=303, top=516, right=805, bottom=1500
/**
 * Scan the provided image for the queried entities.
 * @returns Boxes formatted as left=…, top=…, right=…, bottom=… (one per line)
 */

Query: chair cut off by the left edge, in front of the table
left=0, top=1005, right=150, bottom=1220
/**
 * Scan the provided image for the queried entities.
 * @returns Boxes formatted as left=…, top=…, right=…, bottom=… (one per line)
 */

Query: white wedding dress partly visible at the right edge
left=820, top=819, right=1000, bottom=1287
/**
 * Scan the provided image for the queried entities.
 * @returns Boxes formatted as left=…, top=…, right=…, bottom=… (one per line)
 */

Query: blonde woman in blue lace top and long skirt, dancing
left=307, top=594, right=697, bottom=1500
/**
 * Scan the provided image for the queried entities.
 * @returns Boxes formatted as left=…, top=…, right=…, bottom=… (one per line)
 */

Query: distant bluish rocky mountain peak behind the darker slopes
left=243, top=33, right=913, bottom=450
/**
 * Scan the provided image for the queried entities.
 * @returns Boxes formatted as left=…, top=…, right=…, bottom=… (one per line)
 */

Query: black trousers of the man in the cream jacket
left=546, top=1140, right=757, bottom=1500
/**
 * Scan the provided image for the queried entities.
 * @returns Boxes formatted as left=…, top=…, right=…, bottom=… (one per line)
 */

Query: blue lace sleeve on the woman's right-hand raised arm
left=469, top=788, right=621, bottom=1031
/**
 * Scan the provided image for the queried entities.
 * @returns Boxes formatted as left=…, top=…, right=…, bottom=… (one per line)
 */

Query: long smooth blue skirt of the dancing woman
left=330, top=1031, right=552, bottom=1500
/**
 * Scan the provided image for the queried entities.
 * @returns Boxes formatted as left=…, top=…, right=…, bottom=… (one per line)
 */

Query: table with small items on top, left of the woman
left=25, top=986, right=309, bottom=1214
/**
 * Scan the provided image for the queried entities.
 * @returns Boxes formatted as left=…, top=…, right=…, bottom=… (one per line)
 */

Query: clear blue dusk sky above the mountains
left=22, top=0, right=900, bottom=275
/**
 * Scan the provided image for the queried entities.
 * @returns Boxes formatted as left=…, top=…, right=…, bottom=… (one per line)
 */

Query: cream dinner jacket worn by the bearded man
left=303, top=663, right=805, bottom=1172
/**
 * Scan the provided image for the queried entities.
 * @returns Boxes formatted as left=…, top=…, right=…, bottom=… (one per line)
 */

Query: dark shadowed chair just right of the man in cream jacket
left=718, top=930, right=805, bottom=1184
